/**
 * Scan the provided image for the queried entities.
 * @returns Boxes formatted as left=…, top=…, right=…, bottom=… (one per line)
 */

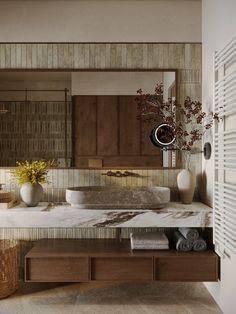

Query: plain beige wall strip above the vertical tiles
left=0, top=0, right=201, bottom=42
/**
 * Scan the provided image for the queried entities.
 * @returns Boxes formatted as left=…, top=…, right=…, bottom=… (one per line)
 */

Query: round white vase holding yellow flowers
left=20, top=182, right=43, bottom=207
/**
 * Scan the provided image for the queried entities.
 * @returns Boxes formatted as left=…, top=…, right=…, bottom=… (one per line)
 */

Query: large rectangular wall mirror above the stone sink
left=0, top=70, right=178, bottom=168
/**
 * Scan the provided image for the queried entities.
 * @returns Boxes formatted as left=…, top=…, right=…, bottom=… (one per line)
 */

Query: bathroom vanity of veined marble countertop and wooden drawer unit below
left=6, top=202, right=219, bottom=282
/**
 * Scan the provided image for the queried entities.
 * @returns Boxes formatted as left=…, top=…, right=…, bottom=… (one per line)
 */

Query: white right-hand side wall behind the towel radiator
left=202, top=0, right=236, bottom=314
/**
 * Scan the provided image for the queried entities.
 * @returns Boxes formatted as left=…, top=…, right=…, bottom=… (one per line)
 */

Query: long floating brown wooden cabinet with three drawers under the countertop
left=25, top=239, right=219, bottom=282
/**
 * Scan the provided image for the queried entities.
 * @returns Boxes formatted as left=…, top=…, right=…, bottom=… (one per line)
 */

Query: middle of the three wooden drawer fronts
left=91, top=257, right=153, bottom=281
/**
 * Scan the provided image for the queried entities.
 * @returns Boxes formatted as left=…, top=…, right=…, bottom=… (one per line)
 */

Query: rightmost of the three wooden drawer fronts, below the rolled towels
left=155, top=256, right=218, bottom=281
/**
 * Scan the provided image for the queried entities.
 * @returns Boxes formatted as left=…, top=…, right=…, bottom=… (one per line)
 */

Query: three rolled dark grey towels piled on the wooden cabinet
left=173, top=228, right=207, bottom=252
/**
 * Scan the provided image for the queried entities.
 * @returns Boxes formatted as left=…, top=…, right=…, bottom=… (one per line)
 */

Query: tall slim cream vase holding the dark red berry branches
left=177, top=169, right=196, bottom=204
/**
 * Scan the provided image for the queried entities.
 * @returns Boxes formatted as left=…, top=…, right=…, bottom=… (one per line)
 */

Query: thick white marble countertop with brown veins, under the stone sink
left=0, top=202, right=212, bottom=228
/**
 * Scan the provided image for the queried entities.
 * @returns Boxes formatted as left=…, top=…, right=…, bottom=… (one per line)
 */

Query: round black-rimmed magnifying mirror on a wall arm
left=150, top=123, right=175, bottom=148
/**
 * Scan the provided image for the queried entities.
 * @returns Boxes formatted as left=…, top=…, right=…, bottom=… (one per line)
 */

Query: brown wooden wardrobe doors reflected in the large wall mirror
left=72, top=96, right=162, bottom=168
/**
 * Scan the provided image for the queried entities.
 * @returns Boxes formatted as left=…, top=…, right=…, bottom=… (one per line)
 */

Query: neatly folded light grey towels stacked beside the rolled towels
left=130, top=231, right=169, bottom=250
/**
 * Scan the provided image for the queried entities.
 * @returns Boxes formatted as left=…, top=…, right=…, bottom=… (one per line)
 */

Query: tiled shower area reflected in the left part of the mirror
left=0, top=72, right=71, bottom=167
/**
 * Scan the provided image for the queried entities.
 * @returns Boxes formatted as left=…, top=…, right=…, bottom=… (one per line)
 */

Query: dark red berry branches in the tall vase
left=136, top=83, right=219, bottom=151
